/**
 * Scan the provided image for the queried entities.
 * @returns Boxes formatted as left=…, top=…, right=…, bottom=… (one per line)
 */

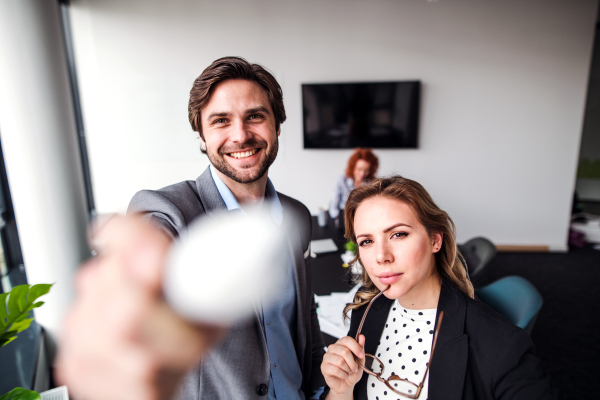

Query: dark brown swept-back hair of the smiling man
left=188, top=57, right=286, bottom=148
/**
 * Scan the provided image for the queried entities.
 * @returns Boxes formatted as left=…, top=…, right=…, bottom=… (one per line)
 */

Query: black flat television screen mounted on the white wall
left=302, top=81, right=421, bottom=149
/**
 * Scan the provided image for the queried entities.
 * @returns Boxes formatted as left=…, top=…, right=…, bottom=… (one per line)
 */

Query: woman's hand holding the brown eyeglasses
left=321, top=335, right=365, bottom=400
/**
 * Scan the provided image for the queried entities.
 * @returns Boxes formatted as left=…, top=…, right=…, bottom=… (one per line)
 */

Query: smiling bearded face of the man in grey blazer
left=201, top=79, right=279, bottom=183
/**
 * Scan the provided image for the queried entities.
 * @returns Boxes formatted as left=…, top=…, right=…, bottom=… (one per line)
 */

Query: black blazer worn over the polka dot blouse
left=321, top=280, right=559, bottom=400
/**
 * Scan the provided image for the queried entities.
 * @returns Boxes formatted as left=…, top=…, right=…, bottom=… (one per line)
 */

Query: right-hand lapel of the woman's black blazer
left=428, top=279, right=469, bottom=400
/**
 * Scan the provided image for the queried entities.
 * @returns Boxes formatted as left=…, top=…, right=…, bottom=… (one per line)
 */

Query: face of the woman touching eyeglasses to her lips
left=354, top=196, right=442, bottom=307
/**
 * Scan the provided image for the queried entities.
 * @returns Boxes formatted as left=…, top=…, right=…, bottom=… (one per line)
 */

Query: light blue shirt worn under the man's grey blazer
left=210, top=165, right=322, bottom=400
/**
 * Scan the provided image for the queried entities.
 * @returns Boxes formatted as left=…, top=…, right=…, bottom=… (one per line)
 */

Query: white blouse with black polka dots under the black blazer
left=367, top=300, right=437, bottom=400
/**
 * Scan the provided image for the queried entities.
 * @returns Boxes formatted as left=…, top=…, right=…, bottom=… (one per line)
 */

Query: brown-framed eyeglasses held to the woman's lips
left=354, top=285, right=444, bottom=399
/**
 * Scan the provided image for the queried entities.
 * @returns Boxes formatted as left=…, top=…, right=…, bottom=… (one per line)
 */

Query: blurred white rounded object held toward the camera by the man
left=163, top=212, right=287, bottom=325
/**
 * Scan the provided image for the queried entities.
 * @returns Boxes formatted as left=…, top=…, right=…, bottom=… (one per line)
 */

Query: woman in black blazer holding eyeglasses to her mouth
left=321, top=176, right=557, bottom=400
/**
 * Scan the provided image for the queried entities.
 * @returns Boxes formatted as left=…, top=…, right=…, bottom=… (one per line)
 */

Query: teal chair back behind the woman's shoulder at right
left=475, top=276, right=544, bottom=334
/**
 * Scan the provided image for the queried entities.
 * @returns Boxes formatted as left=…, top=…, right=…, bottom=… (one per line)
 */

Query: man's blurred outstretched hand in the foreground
left=56, top=216, right=224, bottom=400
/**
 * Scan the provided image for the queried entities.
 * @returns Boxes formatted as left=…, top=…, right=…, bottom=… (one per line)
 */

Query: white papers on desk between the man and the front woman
left=315, top=283, right=362, bottom=339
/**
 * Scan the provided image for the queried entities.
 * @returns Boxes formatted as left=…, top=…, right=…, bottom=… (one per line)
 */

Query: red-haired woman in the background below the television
left=329, top=147, right=379, bottom=218
